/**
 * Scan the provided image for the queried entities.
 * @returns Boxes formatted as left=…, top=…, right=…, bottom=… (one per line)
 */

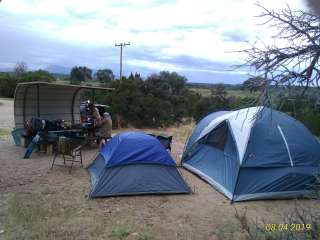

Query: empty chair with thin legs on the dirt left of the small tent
left=50, top=137, right=83, bottom=173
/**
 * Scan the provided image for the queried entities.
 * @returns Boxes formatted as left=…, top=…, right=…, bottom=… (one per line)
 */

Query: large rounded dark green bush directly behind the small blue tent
left=105, top=72, right=199, bottom=127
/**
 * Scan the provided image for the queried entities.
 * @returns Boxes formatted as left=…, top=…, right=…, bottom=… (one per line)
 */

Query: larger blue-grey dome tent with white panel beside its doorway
left=182, top=107, right=320, bottom=201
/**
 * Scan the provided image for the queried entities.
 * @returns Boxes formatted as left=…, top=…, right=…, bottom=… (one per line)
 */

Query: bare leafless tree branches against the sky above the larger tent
left=240, top=5, right=320, bottom=98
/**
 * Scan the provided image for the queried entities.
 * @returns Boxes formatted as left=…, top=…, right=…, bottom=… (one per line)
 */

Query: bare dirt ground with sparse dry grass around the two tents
left=0, top=99, right=320, bottom=240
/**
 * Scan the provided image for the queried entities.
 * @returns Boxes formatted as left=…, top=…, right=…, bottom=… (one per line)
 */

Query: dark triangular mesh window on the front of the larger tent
left=204, top=122, right=229, bottom=151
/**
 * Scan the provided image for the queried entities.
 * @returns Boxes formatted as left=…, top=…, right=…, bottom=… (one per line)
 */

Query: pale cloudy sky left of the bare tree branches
left=0, top=0, right=307, bottom=83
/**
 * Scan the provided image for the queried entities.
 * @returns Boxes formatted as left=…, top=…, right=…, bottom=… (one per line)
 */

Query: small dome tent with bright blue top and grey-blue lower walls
left=88, top=132, right=190, bottom=198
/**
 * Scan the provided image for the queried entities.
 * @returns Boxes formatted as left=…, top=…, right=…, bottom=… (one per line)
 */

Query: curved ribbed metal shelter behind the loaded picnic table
left=14, top=82, right=113, bottom=129
